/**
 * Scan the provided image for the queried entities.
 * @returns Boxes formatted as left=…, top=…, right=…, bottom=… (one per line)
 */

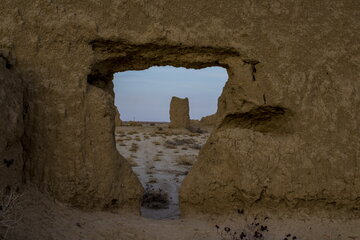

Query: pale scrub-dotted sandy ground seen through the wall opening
left=115, top=123, right=210, bottom=219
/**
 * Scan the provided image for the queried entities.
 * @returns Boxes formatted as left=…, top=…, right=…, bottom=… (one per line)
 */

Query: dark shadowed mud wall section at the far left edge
left=0, top=54, right=25, bottom=189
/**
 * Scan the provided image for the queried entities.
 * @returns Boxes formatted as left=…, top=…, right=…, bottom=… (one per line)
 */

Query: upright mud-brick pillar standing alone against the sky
left=169, top=97, right=190, bottom=128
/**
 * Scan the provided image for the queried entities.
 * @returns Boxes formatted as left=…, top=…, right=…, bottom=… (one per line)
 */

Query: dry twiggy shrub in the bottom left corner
left=0, top=186, right=23, bottom=240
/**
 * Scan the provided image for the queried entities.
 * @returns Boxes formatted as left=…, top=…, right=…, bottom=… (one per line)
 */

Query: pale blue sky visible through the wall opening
left=113, top=66, right=228, bottom=122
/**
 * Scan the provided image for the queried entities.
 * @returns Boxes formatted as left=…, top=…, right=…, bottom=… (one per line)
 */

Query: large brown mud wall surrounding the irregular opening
left=0, top=0, right=360, bottom=214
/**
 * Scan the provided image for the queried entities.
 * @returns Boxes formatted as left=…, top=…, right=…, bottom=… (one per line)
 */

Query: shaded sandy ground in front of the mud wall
left=5, top=187, right=360, bottom=240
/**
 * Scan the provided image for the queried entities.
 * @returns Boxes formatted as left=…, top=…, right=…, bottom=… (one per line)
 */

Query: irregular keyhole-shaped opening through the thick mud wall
left=114, top=66, right=228, bottom=219
